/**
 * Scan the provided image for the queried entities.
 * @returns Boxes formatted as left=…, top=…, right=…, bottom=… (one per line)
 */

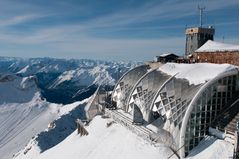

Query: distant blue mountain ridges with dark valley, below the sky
left=0, top=57, right=138, bottom=104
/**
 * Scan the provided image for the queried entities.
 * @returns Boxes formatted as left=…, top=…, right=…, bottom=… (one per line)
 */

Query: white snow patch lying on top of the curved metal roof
left=159, top=63, right=236, bottom=85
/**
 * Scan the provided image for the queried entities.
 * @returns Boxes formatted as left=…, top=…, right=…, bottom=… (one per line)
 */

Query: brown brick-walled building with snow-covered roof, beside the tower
left=193, top=40, right=239, bottom=66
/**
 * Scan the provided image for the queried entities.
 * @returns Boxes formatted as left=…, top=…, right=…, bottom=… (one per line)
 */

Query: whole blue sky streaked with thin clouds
left=0, top=0, right=239, bottom=61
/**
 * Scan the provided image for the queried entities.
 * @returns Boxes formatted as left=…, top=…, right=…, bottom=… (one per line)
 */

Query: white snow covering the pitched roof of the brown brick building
left=196, top=40, right=239, bottom=52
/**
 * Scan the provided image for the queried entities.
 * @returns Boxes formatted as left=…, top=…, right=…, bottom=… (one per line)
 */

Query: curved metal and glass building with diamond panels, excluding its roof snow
left=112, top=62, right=239, bottom=157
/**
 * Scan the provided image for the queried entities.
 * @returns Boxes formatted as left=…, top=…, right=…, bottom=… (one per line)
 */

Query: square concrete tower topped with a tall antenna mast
left=185, top=6, right=215, bottom=56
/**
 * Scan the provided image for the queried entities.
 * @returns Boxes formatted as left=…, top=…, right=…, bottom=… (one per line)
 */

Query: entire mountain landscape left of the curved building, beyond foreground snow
left=0, top=57, right=137, bottom=159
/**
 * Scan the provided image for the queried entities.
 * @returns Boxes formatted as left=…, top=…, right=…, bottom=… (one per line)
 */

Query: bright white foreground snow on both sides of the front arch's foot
left=15, top=113, right=233, bottom=159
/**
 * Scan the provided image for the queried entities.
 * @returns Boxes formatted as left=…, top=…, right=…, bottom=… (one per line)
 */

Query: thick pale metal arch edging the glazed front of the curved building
left=179, top=69, right=238, bottom=158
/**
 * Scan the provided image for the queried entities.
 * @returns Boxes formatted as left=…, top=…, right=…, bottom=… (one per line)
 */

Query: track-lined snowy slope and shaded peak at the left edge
left=0, top=74, right=89, bottom=159
